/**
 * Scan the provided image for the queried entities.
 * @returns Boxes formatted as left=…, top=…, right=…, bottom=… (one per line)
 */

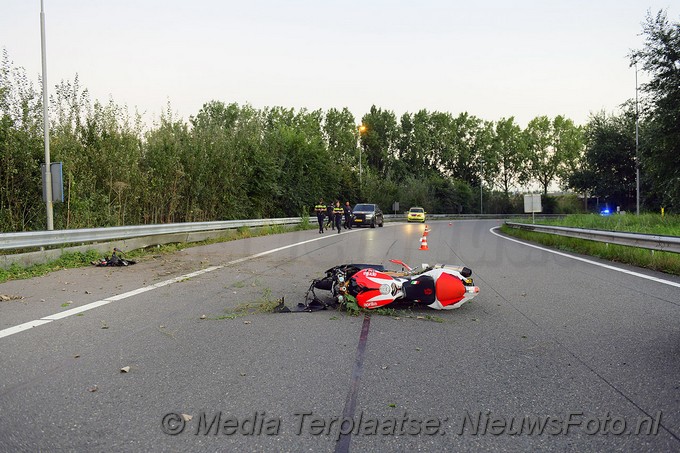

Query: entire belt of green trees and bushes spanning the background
left=0, top=12, right=680, bottom=231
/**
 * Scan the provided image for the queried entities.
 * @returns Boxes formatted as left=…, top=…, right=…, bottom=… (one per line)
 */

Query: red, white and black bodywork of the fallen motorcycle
left=349, top=265, right=479, bottom=310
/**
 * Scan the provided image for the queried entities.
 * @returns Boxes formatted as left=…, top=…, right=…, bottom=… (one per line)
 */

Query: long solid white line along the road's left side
left=0, top=231, right=362, bottom=338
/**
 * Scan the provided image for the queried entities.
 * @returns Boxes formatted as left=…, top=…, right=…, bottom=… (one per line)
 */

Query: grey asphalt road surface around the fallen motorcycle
left=0, top=221, right=680, bottom=452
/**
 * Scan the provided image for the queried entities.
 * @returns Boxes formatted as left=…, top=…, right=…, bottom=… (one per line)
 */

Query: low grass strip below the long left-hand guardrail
left=0, top=219, right=314, bottom=283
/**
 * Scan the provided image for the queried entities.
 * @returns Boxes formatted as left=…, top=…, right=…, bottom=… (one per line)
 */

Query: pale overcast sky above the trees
left=0, top=0, right=680, bottom=126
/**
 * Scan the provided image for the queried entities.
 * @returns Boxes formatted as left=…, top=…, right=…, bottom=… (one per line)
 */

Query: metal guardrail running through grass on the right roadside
left=505, top=222, right=680, bottom=253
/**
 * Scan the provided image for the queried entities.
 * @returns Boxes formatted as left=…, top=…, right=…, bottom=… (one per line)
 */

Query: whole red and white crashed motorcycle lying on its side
left=305, top=260, right=479, bottom=310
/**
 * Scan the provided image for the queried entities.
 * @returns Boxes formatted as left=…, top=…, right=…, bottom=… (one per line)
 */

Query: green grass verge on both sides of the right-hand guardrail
left=501, top=214, right=680, bottom=275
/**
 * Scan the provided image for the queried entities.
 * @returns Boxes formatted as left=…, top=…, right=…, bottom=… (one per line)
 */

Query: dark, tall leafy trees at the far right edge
left=566, top=11, right=680, bottom=212
